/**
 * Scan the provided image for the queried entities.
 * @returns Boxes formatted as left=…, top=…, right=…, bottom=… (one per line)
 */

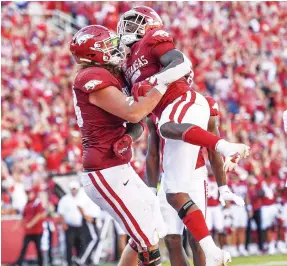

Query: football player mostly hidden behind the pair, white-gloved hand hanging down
left=153, top=97, right=244, bottom=266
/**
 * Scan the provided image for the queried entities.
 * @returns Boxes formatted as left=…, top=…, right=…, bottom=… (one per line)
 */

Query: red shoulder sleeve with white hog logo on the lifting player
left=75, top=68, right=118, bottom=93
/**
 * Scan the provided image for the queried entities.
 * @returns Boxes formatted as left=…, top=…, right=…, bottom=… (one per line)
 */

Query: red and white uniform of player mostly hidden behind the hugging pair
left=158, top=97, right=218, bottom=235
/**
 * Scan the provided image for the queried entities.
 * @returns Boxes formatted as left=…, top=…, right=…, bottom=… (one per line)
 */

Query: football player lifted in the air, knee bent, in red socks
left=118, top=6, right=249, bottom=266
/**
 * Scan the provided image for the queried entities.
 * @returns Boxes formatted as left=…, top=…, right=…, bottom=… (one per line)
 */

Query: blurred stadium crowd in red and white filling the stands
left=1, top=1, right=287, bottom=260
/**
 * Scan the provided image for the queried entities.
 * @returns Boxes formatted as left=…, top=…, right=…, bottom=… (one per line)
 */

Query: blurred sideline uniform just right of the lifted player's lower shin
left=206, top=176, right=224, bottom=233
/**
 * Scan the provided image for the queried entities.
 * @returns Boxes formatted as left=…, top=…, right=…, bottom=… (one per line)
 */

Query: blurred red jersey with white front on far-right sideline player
left=262, top=176, right=280, bottom=206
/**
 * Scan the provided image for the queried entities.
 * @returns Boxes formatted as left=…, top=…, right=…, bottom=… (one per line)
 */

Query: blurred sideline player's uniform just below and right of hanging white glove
left=229, top=180, right=248, bottom=228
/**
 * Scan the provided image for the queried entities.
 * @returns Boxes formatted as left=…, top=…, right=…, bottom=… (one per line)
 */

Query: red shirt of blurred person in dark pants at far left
left=23, top=198, right=44, bottom=235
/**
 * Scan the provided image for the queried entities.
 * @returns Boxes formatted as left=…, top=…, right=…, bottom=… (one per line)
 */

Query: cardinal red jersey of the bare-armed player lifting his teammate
left=73, top=67, right=128, bottom=171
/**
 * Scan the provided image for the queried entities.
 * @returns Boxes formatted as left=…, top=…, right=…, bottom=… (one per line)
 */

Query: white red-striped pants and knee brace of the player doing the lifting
left=82, top=165, right=165, bottom=265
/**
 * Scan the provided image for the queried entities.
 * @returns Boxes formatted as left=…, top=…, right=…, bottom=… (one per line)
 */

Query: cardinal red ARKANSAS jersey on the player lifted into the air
left=123, top=29, right=195, bottom=118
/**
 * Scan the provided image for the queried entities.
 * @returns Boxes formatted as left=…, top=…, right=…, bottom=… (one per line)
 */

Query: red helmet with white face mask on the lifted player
left=117, top=6, right=163, bottom=45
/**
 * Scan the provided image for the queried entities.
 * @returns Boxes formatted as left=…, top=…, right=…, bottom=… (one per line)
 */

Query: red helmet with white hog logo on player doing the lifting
left=70, top=25, right=124, bottom=65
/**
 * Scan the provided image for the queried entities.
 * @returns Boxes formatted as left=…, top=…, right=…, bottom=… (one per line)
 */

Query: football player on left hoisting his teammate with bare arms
left=70, top=25, right=170, bottom=265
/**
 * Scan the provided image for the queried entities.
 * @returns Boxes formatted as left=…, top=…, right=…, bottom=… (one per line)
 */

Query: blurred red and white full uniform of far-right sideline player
left=261, top=177, right=280, bottom=230
